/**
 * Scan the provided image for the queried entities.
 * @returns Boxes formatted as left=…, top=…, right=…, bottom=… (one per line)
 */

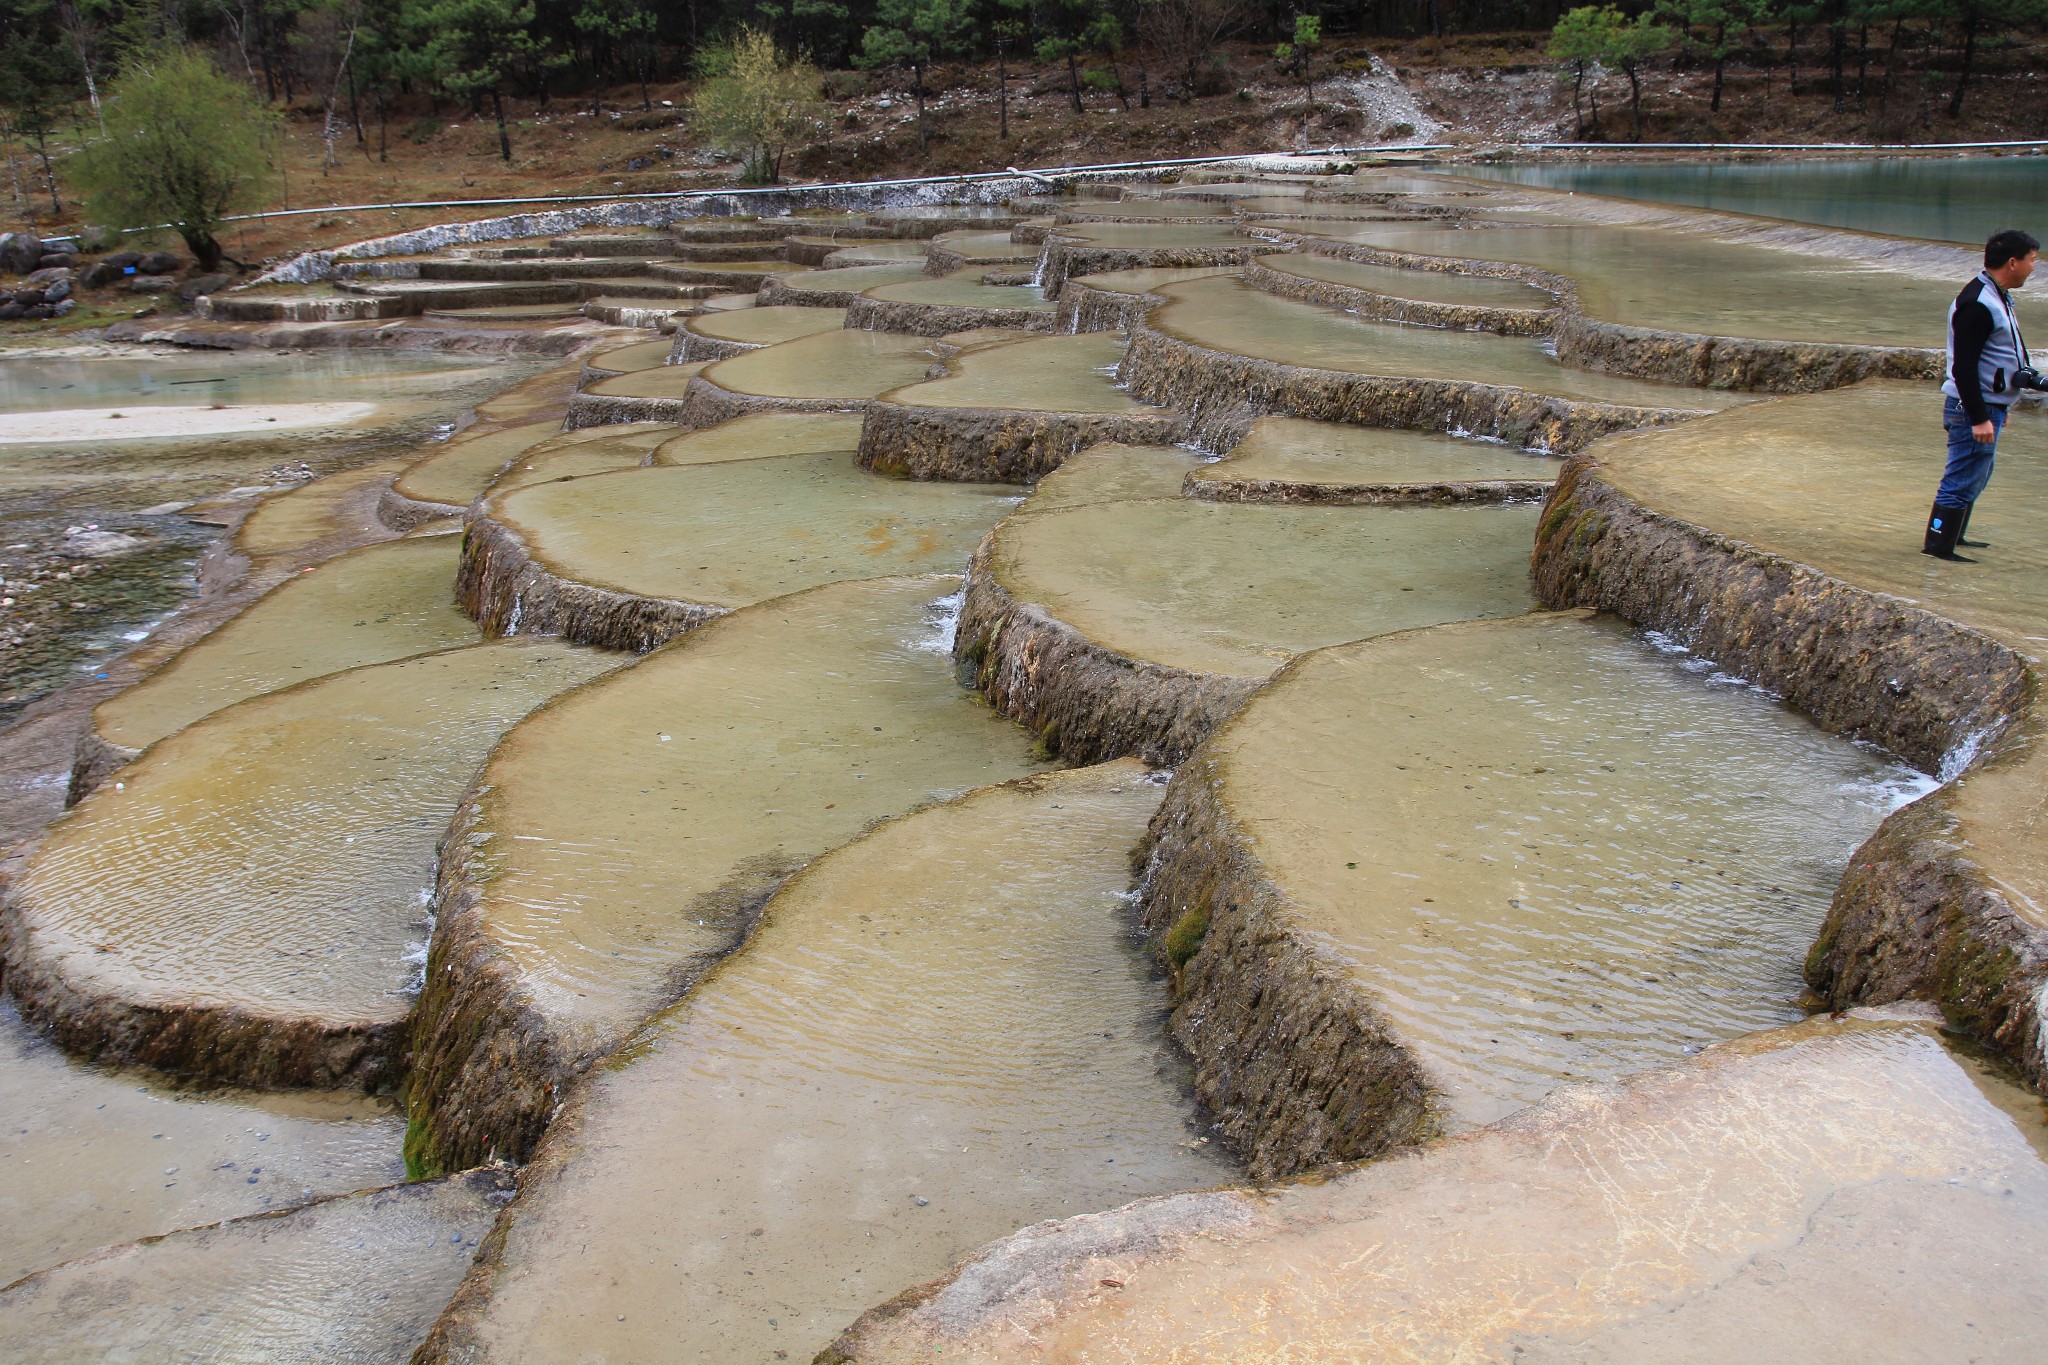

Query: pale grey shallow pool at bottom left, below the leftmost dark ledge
left=0, top=1003, right=406, bottom=1285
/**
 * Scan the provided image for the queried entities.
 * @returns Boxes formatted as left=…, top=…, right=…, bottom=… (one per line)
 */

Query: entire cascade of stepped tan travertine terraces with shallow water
left=0, top=170, right=2048, bottom=1365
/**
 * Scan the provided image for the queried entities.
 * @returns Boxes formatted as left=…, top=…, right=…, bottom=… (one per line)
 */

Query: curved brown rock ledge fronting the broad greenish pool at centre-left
left=455, top=499, right=727, bottom=653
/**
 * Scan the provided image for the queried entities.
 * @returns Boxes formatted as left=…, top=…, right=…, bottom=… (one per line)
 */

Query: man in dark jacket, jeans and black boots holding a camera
left=1921, top=227, right=2048, bottom=565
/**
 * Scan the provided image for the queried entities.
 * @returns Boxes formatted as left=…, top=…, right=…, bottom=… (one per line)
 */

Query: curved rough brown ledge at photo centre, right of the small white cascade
left=952, top=534, right=1262, bottom=767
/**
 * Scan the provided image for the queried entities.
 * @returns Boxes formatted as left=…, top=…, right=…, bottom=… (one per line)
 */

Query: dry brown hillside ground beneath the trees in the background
left=4, top=33, right=2048, bottom=274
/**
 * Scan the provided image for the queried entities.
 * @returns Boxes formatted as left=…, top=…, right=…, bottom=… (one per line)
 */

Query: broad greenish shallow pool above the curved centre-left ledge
left=487, top=452, right=1016, bottom=608
